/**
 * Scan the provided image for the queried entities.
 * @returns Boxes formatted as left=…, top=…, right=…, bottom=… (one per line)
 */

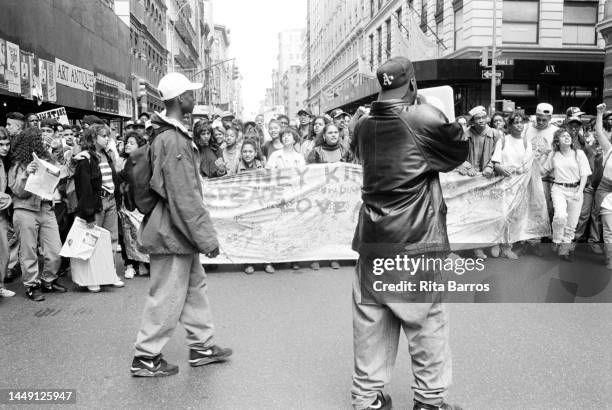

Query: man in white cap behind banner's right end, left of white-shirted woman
left=524, top=103, right=558, bottom=256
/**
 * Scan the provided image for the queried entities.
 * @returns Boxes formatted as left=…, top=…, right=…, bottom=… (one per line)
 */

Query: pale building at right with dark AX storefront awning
left=307, top=0, right=604, bottom=114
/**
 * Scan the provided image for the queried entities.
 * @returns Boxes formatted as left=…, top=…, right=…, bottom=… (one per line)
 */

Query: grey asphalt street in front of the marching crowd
left=0, top=256, right=612, bottom=409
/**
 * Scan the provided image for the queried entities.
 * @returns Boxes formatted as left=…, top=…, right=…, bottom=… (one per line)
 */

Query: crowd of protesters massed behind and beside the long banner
left=0, top=96, right=612, bottom=301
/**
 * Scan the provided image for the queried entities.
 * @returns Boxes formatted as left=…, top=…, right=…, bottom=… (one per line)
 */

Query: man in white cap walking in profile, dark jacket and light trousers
left=131, top=73, right=232, bottom=377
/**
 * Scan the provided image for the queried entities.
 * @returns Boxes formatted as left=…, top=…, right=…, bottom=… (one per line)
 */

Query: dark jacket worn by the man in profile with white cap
left=138, top=114, right=219, bottom=255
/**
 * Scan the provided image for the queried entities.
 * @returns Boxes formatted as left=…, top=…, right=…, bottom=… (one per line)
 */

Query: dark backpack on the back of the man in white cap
left=124, top=125, right=174, bottom=215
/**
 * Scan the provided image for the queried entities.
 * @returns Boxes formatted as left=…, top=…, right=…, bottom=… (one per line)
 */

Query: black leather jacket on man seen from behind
left=352, top=100, right=468, bottom=255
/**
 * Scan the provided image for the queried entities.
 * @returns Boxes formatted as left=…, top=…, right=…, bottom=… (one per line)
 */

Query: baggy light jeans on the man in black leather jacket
left=351, top=261, right=452, bottom=410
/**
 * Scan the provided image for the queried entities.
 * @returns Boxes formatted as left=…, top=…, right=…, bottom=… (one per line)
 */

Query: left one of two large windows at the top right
left=502, top=0, right=540, bottom=44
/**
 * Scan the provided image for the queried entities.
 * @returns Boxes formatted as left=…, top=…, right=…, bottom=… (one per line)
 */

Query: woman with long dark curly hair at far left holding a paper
left=9, top=127, right=66, bottom=302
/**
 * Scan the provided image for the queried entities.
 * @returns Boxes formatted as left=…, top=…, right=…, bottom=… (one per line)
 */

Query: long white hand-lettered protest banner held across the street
left=191, top=163, right=550, bottom=263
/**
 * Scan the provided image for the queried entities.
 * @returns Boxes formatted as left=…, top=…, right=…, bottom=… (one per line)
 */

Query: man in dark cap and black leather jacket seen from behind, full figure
left=351, top=57, right=468, bottom=410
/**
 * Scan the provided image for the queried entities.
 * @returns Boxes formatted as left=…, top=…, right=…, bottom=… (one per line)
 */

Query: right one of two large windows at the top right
left=563, top=1, right=598, bottom=45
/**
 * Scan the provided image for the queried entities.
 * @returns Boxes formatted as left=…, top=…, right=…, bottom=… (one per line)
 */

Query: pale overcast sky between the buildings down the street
left=213, top=0, right=306, bottom=119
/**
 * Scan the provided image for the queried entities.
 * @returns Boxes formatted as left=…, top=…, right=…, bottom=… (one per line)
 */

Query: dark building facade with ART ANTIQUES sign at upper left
left=0, top=0, right=133, bottom=123
